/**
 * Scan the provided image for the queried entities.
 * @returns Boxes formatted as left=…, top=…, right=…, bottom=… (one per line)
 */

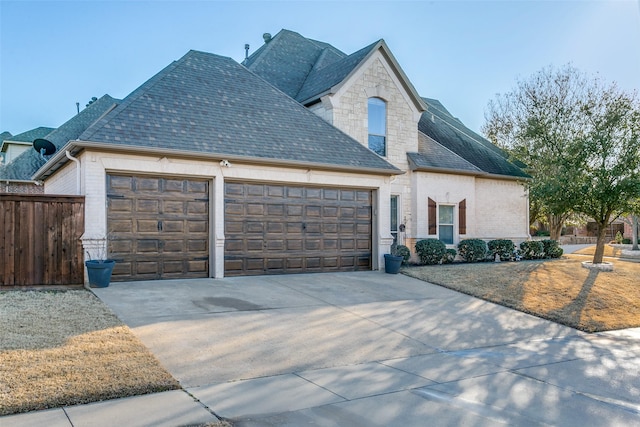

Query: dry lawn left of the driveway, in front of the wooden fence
left=0, top=290, right=180, bottom=415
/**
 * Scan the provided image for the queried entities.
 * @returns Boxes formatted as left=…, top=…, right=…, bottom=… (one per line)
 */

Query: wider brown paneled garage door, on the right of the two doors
left=225, top=182, right=372, bottom=276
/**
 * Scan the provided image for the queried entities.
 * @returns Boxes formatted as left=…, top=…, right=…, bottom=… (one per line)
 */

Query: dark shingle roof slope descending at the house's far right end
left=418, top=98, right=529, bottom=178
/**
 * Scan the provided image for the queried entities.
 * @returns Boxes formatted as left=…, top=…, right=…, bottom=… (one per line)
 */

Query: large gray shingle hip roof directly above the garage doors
left=80, top=51, right=399, bottom=174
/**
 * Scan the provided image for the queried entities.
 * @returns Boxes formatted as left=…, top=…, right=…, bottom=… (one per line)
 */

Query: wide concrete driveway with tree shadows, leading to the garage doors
left=94, top=272, right=640, bottom=427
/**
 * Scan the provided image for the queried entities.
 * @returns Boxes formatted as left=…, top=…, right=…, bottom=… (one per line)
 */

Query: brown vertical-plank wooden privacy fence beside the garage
left=0, top=194, right=84, bottom=287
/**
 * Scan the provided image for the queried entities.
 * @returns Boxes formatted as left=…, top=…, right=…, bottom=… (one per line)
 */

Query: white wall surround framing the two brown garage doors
left=45, top=150, right=391, bottom=277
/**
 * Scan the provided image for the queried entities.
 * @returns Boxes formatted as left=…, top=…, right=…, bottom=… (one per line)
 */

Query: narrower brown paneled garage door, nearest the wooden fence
left=106, top=175, right=209, bottom=281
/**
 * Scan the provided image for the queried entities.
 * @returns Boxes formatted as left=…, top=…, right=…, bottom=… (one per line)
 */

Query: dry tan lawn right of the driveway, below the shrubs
left=402, top=255, right=640, bottom=332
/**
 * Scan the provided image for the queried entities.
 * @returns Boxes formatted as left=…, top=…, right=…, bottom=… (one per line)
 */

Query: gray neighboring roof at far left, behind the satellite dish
left=0, top=95, right=118, bottom=181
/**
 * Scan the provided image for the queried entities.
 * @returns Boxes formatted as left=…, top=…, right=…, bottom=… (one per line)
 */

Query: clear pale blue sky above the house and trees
left=0, top=0, right=640, bottom=135
